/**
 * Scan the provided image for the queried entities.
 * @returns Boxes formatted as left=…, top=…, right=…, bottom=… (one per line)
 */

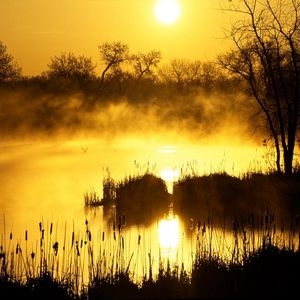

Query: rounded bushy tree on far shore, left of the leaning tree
left=46, top=52, right=95, bottom=81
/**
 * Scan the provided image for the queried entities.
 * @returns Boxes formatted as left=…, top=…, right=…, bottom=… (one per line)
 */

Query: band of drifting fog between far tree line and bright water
left=0, top=89, right=261, bottom=144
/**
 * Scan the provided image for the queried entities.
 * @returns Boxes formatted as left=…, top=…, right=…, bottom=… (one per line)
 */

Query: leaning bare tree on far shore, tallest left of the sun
left=98, top=42, right=130, bottom=88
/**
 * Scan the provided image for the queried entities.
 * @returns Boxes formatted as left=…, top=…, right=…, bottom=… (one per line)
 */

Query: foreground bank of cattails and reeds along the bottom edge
left=0, top=209, right=300, bottom=300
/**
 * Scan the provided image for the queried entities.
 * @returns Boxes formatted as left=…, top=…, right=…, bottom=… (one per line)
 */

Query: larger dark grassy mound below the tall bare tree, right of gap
left=173, top=172, right=300, bottom=226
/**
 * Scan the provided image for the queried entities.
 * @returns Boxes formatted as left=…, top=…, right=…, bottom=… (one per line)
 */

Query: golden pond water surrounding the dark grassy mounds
left=0, top=138, right=270, bottom=284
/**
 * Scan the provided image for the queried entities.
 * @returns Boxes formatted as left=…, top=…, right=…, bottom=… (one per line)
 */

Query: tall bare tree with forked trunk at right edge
left=219, top=0, right=300, bottom=174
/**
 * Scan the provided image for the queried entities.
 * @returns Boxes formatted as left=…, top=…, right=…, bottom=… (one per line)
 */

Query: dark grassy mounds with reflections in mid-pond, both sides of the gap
left=89, top=172, right=300, bottom=228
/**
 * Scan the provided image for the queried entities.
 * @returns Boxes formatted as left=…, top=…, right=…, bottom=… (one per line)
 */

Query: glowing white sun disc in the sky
left=154, top=0, right=180, bottom=25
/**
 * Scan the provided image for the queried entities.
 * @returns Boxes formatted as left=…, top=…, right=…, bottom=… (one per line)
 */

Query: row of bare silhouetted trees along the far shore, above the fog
left=0, top=41, right=234, bottom=92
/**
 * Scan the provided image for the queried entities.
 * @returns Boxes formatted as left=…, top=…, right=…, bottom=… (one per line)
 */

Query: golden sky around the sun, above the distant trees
left=0, top=0, right=233, bottom=75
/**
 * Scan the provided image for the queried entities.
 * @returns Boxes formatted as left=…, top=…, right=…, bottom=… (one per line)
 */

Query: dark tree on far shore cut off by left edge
left=0, top=41, right=21, bottom=82
